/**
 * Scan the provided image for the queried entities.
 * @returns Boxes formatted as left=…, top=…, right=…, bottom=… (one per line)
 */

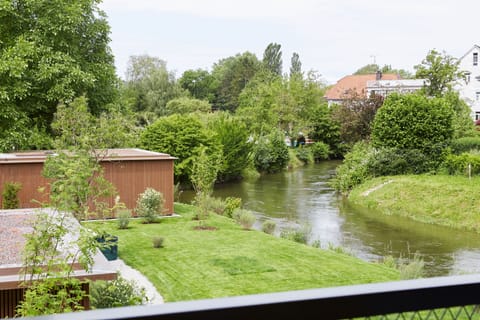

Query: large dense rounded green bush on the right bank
left=372, top=94, right=454, bottom=154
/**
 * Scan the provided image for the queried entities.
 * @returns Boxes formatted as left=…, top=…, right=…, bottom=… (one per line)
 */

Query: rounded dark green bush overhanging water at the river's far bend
left=253, top=131, right=289, bottom=173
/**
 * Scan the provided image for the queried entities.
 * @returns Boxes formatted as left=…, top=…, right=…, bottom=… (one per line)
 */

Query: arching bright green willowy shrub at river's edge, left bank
left=209, top=113, right=253, bottom=181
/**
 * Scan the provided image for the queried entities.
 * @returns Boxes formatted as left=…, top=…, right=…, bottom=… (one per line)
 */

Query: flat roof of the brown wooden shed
left=0, top=148, right=176, bottom=164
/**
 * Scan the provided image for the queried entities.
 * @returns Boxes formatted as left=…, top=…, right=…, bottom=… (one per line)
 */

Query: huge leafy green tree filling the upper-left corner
left=0, top=0, right=118, bottom=141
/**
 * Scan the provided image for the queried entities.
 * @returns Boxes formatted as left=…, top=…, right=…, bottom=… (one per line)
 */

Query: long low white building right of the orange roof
left=367, top=79, right=428, bottom=97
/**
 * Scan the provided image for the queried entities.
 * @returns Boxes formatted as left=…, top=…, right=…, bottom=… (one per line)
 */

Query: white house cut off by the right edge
left=456, top=45, right=480, bottom=120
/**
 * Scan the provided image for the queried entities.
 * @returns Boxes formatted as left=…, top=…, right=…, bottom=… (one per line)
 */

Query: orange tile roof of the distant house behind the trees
left=325, top=73, right=400, bottom=100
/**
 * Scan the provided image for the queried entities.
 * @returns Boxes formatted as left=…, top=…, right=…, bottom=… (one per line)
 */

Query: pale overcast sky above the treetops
left=100, top=0, right=480, bottom=83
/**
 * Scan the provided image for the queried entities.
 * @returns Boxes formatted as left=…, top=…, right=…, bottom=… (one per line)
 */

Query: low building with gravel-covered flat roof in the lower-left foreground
left=0, top=209, right=117, bottom=319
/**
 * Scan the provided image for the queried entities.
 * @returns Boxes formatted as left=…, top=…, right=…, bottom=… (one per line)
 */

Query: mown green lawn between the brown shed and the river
left=87, top=204, right=398, bottom=302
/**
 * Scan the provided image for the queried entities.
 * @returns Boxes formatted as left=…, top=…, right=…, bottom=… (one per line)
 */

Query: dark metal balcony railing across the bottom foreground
left=28, top=275, right=480, bottom=320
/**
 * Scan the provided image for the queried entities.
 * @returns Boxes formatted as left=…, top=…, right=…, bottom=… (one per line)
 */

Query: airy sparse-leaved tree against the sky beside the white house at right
left=415, top=50, right=465, bottom=97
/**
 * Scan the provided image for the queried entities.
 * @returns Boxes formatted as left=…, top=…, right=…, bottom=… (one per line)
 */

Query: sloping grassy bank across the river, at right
left=349, top=175, right=480, bottom=232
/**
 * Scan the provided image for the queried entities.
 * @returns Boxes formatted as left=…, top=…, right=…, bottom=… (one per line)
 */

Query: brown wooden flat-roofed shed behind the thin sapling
left=0, top=149, right=175, bottom=214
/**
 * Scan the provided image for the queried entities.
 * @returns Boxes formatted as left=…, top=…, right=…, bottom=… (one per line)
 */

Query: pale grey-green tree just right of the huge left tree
left=126, top=55, right=185, bottom=116
